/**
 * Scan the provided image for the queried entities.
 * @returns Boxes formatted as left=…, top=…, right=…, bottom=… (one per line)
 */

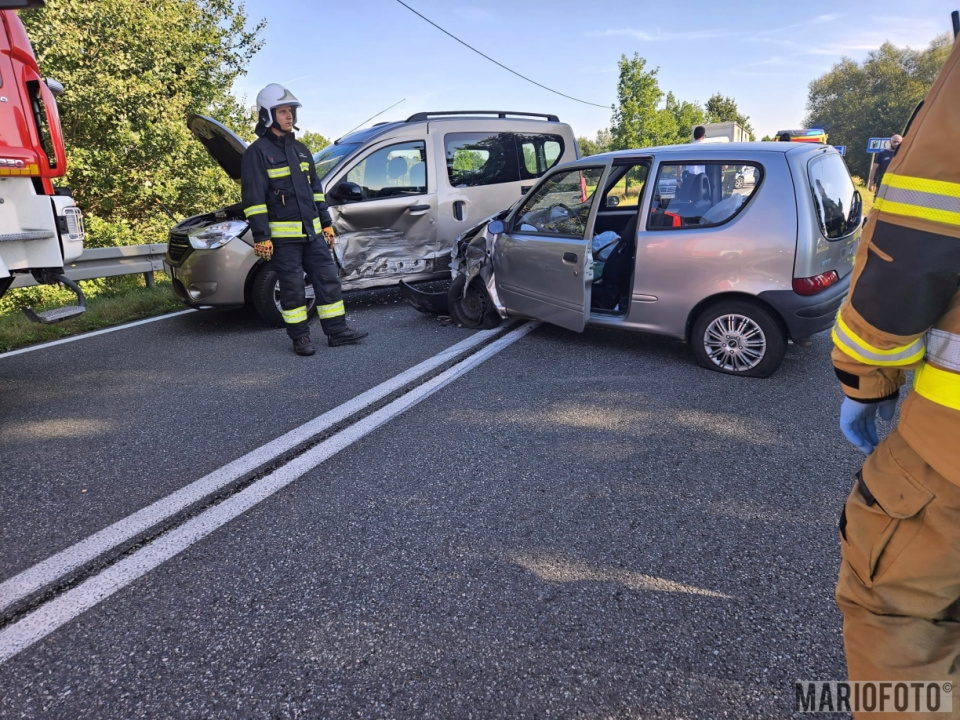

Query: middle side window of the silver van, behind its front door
left=443, top=133, right=520, bottom=187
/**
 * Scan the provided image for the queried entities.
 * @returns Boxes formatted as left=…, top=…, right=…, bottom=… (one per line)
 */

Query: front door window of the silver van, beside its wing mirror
left=347, top=141, right=427, bottom=200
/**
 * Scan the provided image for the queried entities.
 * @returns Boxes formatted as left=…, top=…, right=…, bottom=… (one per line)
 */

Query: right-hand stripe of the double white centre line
left=0, top=322, right=538, bottom=665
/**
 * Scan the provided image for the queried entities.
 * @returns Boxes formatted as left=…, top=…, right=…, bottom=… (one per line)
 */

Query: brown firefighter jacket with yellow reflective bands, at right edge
left=833, top=33, right=960, bottom=485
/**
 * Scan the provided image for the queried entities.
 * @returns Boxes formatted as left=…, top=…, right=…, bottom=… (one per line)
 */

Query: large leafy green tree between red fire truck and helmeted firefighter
left=21, top=0, right=264, bottom=246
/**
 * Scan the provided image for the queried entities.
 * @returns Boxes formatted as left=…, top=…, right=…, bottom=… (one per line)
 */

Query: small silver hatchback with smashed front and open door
left=405, top=142, right=862, bottom=377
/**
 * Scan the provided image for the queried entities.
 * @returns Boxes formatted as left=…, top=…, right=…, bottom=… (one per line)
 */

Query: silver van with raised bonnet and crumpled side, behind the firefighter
left=164, top=111, right=579, bottom=326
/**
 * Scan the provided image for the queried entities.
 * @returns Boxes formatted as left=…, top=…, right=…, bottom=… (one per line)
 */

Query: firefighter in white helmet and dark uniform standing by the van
left=240, top=83, right=367, bottom=355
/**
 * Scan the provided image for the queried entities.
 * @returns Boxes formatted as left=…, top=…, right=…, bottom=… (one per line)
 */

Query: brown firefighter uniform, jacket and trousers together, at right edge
left=833, top=29, right=960, bottom=718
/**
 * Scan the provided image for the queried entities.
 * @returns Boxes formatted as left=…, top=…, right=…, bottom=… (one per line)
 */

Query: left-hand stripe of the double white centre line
left=0, top=330, right=516, bottom=611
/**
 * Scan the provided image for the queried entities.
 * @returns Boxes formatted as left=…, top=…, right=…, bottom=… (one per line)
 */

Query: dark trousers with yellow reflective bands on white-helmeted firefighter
left=273, top=238, right=347, bottom=340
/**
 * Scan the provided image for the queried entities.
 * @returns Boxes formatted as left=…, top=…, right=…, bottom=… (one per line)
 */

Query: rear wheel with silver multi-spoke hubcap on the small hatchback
left=690, top=300, right=787, bottom=377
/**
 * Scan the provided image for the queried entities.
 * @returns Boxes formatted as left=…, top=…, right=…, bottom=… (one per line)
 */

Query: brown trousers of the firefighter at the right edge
left=836, top=429, right=960, bottom=720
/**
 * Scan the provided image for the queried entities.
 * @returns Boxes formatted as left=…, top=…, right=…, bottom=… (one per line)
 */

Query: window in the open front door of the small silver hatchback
left=515, top=167, right=603, bottom=237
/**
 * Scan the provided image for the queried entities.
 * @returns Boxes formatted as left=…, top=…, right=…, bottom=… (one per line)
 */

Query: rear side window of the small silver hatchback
left=647, top=161, right=763, bottom=230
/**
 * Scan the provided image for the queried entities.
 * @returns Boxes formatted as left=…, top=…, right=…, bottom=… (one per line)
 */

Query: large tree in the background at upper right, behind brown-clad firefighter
left=804, top=35, right=952, bottom=178
